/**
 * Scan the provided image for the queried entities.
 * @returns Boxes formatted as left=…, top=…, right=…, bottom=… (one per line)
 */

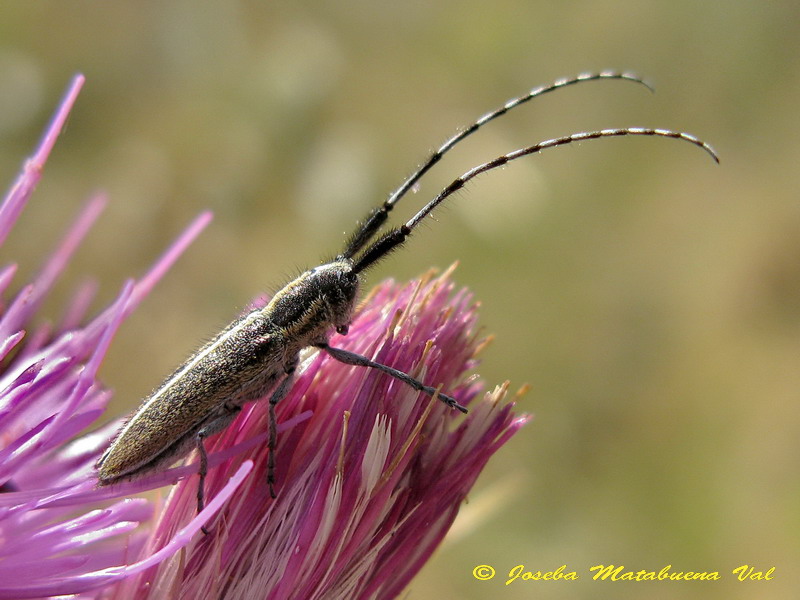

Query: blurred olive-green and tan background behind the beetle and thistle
left=0, top=0, right=800, bottom=599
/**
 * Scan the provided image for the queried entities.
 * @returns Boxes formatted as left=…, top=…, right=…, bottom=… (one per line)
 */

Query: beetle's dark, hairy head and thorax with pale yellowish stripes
left=262, top=259, right=359, bottom=347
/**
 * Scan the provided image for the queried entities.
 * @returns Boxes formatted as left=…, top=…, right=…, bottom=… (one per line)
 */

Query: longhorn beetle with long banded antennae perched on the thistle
left=97, top=71, right=719, bottom=511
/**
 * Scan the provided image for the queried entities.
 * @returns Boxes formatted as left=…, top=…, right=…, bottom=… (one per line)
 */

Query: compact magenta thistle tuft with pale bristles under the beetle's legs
left=117, top=272, right=526, bottom=599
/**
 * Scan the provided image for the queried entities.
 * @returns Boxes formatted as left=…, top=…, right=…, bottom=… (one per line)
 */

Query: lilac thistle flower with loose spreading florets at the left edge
left=0, top=76, right=241, bottom=598
